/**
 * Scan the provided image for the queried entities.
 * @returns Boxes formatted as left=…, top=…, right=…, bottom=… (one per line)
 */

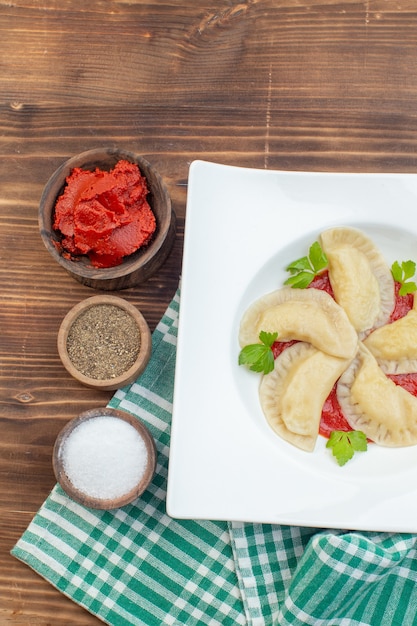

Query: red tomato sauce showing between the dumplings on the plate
left=272, top=271, right=417, bottom=438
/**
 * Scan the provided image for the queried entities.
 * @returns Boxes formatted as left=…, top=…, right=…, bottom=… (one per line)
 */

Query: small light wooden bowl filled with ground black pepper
left=58, top=295, right=151, bottom=390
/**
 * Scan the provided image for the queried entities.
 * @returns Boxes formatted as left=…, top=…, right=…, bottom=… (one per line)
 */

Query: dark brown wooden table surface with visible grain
left=0, top=0, right=417, bottom=626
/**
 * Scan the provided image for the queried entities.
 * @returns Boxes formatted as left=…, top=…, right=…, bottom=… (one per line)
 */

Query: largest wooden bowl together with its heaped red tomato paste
left=39, top=148, right=175, bottom=291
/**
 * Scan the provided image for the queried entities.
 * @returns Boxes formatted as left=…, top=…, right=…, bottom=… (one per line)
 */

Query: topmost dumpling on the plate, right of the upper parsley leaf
left=320, top=227, right=395, bottom=338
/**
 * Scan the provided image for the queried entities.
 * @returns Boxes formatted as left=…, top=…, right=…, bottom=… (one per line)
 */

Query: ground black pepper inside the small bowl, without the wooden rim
left=67, top=304, right=140, bottom=380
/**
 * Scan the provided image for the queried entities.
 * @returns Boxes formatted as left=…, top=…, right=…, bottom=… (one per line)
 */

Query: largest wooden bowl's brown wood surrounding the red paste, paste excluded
left=39, top=148, right=176, bottom=291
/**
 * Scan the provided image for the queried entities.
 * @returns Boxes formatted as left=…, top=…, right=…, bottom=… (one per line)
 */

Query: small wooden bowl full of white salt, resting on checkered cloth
left=52, top=407, right=157, bottom=510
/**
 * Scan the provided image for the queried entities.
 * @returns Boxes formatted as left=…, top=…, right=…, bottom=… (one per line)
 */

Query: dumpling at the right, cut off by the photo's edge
left=364, top=298, right=417, bottom=374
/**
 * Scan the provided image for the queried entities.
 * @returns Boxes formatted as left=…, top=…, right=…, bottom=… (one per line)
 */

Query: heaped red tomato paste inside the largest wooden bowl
left=53, top=160, right=156, bottom=267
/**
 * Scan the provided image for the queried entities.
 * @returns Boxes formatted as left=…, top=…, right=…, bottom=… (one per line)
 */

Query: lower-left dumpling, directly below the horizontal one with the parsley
left=259, top=342, right=349, bottom=452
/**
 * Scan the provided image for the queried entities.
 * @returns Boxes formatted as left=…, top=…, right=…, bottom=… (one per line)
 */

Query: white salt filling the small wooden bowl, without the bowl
left=61, top=415, right=148, bottom=500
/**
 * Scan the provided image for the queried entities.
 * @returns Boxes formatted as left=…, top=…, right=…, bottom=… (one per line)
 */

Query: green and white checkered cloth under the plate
left=12, top=292, right=417, bottom=626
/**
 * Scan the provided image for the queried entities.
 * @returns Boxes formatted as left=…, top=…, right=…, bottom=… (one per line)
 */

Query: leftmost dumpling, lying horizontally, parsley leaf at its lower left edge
left=239, top=287, right=358, bottom=358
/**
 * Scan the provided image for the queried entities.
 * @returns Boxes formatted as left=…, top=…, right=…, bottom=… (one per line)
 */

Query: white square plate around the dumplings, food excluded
left=167, top=161, right=417, bottom=532
